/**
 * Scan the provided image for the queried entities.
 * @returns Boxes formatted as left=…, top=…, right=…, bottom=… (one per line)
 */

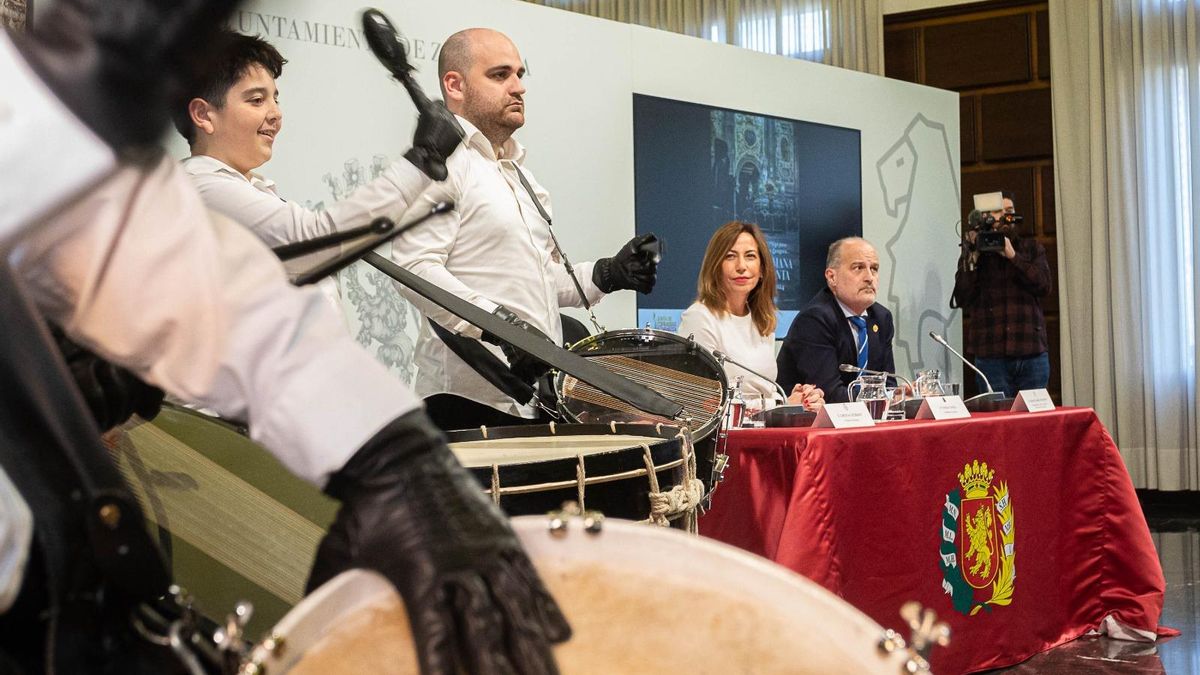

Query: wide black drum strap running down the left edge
left=0, top=264, right=170, bottom=670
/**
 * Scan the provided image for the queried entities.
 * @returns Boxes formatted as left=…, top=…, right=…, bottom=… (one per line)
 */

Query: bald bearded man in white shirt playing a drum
left=392, top=29, right=656, bottom=429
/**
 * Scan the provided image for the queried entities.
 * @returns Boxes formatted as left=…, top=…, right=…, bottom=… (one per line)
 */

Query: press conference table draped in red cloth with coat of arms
left=700, top=408, right=1164, bottom=673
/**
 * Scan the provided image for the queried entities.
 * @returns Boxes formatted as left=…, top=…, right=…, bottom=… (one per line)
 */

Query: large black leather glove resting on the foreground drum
left=308, top=411, right=571, bottom=675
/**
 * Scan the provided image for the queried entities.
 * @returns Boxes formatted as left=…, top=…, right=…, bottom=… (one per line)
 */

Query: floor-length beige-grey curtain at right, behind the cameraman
left=1049, top=0, right=1200, bottom=490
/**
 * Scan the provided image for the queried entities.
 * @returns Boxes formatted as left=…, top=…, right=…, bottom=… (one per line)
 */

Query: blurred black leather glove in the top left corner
left=13, top=0, right=238, bottom=150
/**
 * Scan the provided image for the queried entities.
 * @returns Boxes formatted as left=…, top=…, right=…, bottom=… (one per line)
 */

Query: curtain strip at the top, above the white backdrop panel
left=526, top=0, right=883, bottom=74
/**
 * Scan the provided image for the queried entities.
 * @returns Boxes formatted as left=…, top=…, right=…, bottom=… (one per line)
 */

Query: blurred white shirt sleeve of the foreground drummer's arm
left=14, top=157, right=420, bottom=485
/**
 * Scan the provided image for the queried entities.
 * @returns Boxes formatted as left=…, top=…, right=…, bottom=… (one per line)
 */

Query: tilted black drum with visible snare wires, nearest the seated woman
left=554, top=328, right=730, bottom=492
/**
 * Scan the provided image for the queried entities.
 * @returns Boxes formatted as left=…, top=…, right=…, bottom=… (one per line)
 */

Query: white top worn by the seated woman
left=678, top=303, right=782, bottom=402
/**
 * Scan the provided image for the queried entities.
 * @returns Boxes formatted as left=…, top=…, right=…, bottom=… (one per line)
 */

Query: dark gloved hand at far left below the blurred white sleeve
left=50, top=327, right=163, bottom=431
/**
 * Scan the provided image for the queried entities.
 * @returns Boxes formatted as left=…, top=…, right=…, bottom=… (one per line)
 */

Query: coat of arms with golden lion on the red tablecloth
left=938, top=460, right=1016, bottom=615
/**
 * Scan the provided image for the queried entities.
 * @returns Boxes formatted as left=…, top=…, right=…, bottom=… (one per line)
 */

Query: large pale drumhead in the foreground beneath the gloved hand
left=252, top=516, right=906, bottom=675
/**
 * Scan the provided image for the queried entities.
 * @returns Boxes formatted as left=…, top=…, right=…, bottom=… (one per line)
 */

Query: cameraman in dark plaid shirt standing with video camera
left=950, top=192, right=1050, bottom=396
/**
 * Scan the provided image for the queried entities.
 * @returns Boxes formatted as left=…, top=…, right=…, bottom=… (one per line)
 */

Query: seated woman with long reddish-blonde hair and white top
left=679, top=221, right=824, bottom=410
